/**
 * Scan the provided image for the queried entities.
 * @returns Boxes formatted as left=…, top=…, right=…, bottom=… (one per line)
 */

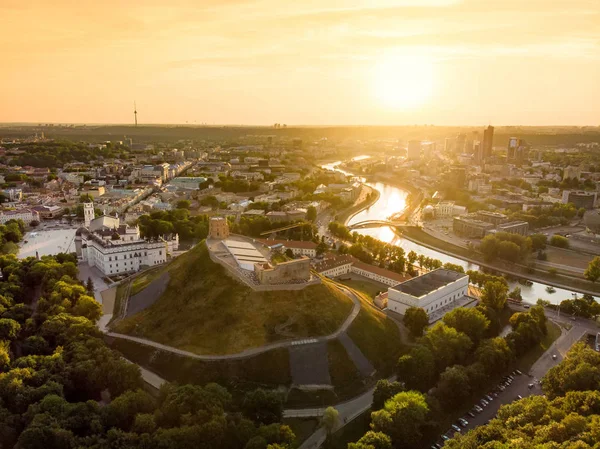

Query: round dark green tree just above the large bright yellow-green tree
left=398, top=345, right=437, bottom=390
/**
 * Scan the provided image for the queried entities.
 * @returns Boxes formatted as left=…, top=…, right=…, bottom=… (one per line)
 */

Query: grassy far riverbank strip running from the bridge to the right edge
left=394, top=226, right=600, bottom=299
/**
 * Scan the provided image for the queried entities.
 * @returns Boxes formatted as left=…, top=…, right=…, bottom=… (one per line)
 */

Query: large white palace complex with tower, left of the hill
left=75, top=203, right=179, bottom=276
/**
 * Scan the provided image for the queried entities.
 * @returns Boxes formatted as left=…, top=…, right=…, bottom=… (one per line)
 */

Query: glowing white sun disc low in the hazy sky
left=373, top=52, right=434, bottom=110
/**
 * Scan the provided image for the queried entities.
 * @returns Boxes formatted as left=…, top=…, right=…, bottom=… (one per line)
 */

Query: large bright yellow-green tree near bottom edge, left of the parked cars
left=371, top=391, right=429, bottom=449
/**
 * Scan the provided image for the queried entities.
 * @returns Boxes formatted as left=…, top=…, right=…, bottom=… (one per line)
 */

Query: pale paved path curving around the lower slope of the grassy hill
left=106, top=285, right=361, bottom=361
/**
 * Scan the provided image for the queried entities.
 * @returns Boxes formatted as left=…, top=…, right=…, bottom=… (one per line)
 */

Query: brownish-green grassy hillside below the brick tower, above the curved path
left=115, top=242, right=353, bottom=354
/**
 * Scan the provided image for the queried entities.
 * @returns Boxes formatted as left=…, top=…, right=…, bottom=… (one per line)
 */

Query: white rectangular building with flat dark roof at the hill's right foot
left=388, top=268, right=469, bottom=315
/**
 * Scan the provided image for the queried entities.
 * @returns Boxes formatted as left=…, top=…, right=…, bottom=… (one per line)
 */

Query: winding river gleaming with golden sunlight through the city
left=321, top=156, right=588, bottom=304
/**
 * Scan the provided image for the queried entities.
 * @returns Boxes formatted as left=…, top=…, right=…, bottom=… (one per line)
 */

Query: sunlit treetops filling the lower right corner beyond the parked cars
left=445, top=343, right=600, bottom=449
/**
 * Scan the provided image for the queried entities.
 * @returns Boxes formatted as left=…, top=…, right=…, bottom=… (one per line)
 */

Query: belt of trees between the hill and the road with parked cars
left=349, top=300, right=546, bottom=449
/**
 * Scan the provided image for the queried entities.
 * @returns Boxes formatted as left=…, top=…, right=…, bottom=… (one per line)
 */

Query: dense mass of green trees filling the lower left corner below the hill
left=0, top=255, right=295, bottom=449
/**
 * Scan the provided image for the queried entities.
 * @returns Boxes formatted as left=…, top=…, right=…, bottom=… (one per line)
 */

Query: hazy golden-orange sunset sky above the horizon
left=0, top=0, right=600, bottom=126
